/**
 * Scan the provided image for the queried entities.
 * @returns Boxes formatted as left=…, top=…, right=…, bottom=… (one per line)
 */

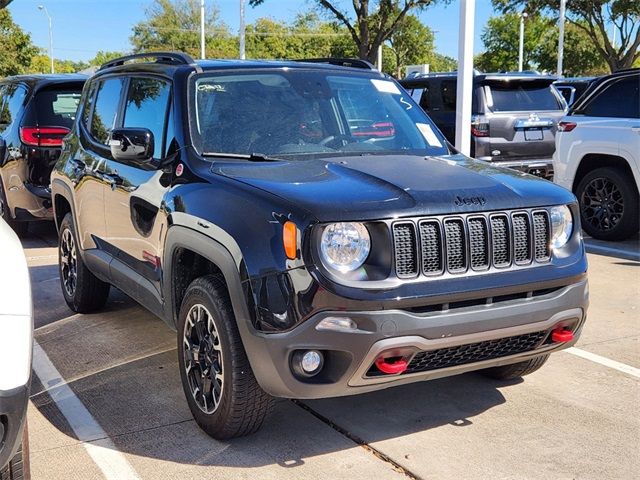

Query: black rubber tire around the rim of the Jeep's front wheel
left=178, top=275, right=273, bottom=440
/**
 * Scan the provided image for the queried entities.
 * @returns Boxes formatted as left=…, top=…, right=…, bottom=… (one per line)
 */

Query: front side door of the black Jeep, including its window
left=103, top=76, right=172, bottom=305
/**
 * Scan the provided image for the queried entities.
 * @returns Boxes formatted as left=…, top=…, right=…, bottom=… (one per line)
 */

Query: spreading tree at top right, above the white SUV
left=492, top=0, right=640, bottom=72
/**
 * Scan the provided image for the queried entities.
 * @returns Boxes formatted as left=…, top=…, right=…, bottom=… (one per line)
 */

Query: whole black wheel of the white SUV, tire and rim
left=576, top=167, right=640, bottom=240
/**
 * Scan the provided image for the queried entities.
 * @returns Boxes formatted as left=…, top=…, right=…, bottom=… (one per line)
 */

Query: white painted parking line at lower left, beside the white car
left=33, top=340, right=140, bottom=480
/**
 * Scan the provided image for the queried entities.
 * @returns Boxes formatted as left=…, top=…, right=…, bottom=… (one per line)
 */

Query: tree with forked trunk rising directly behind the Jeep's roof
left=249, top=0, right=449, bottom=62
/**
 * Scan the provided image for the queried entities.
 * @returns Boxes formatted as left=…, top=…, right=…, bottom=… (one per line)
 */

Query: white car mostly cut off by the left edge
left=0, top=219, right=33, bottom=480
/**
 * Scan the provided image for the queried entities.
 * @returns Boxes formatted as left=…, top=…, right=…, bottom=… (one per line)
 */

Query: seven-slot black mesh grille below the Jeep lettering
left=392, top=210, right=551, bottom=278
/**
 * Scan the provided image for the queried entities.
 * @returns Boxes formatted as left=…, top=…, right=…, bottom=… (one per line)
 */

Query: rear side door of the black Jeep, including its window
left=73, top=77, right=126, bottom=249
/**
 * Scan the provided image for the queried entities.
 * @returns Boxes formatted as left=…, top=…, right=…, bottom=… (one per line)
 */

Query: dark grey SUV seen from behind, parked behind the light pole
left=400, top=72, right=566, bottom=179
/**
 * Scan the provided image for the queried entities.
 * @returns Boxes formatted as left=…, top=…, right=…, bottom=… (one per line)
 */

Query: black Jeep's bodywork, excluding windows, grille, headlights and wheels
left=52, top=53, right=588, bottom=398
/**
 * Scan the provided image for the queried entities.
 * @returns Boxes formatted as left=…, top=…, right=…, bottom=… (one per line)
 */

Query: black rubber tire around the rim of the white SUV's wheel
left=576, top=167, right=640, bottom=240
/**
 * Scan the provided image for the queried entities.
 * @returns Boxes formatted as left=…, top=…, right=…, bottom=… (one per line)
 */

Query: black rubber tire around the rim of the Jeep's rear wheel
left=58, top=213, right=111, bottom=313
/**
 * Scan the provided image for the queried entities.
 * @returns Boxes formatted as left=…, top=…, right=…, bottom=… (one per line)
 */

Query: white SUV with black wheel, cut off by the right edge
left=554, top=68, right=640, bottom=240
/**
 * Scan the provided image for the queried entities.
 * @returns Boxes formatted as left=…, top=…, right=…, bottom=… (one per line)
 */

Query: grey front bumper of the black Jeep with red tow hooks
left=245, top=277, right=588, bottom=398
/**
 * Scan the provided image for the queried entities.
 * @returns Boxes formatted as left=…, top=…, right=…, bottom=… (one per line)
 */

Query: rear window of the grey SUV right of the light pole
left=487, top=83, right=562, bottom=112
